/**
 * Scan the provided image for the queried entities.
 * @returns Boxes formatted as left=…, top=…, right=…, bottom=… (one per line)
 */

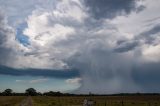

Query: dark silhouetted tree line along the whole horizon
left=0, top=88, right=160, bottom=96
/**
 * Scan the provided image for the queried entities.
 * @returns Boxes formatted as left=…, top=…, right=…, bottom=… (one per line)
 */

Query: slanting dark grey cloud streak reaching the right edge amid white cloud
left=113, top=25, right=160, bottom=53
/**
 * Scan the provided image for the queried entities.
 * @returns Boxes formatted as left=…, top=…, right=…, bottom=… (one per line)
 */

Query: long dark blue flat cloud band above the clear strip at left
left=0, top=65, right=79, bottom=78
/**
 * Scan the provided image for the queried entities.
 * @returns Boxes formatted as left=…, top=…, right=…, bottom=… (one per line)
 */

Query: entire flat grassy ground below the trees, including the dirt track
left=0, top=96, right=160, bottom=106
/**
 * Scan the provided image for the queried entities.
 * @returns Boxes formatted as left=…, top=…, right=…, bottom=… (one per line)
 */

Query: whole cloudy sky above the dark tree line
left=0, top=0, right=160, bottom=94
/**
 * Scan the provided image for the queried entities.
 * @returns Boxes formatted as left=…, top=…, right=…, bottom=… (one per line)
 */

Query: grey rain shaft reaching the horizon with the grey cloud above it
left=51, top=16, right=160, bottom=94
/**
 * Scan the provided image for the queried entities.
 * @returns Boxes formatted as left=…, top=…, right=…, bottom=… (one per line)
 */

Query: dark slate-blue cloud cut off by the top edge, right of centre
left=84, top=0, right=144, bottom=19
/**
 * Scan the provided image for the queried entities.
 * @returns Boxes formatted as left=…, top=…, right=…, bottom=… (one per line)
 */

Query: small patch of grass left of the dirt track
left=0, top=96, right=25, bottom=106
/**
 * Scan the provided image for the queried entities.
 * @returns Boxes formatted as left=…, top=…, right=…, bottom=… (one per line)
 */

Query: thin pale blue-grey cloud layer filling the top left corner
left=0, top=0, right=57, bottom=27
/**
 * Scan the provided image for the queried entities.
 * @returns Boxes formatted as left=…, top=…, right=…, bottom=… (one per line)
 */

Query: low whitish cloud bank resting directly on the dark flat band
left=10, top=54, right=66, bottom=69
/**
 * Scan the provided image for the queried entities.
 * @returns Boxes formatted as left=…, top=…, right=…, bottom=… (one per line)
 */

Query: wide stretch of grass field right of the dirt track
left=32, top=96, right=160, bottom=106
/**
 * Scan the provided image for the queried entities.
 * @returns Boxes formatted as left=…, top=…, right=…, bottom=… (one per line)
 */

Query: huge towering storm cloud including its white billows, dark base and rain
left=0, top=0, right=160, bottom=93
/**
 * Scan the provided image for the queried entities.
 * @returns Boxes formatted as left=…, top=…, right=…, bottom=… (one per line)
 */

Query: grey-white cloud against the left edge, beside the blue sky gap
left=0, top=10, right=27, bottom=66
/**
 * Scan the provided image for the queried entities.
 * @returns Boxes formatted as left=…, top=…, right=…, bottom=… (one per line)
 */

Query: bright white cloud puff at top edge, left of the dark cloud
left=52, top=0, right=87, bottom=22
